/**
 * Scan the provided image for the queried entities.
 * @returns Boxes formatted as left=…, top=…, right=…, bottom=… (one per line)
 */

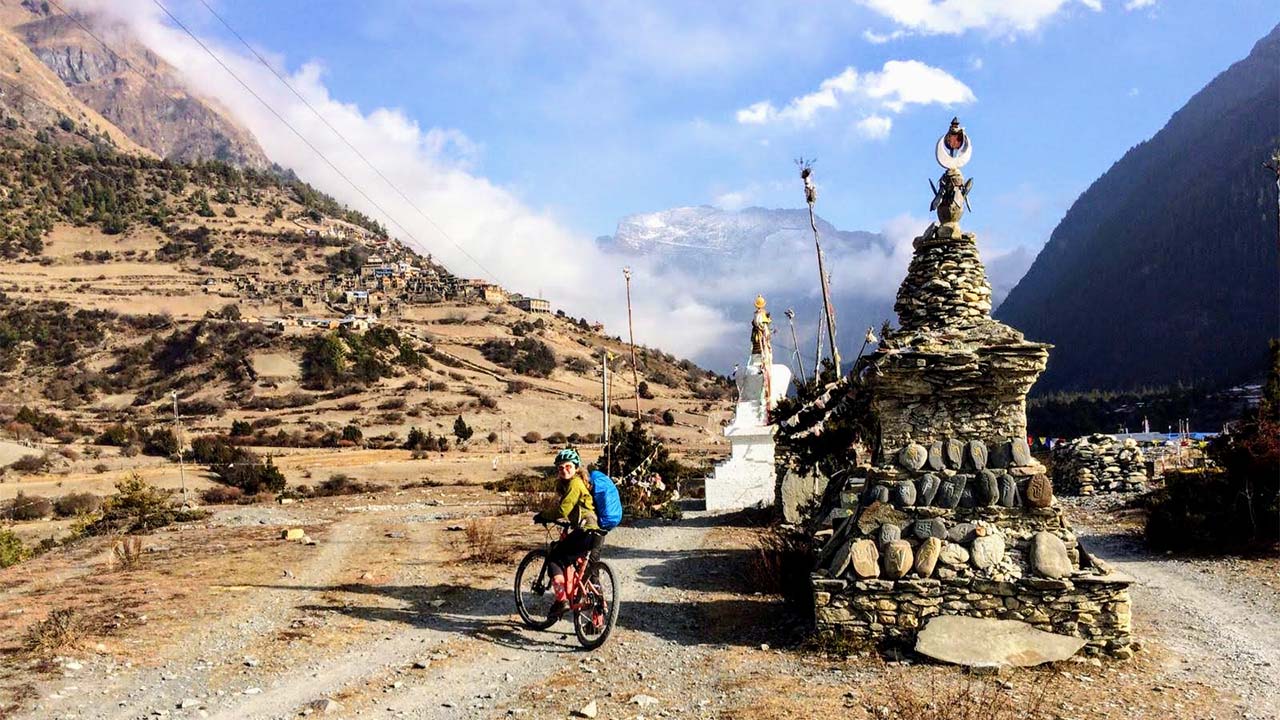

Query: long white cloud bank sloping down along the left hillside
left=72, top=0, right=730, bottom=356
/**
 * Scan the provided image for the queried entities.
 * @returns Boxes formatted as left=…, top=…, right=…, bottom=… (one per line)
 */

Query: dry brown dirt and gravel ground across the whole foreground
left=0, top=486, right=1280, bottom=720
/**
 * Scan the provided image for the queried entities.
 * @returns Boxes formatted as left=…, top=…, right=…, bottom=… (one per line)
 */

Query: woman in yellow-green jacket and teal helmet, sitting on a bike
left=534, top=447, right=604, bottom=618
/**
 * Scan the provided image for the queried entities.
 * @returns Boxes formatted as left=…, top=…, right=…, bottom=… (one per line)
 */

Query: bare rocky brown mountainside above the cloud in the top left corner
left=0, top=0, right=270, bottom=168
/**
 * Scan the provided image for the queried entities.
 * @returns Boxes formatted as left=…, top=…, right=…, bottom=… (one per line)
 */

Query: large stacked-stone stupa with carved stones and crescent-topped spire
left=788, top=120, right=1130, bottom=657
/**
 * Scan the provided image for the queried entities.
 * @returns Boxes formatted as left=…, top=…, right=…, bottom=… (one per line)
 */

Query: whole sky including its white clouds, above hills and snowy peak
left=94, top=0, right=1280, bottom=359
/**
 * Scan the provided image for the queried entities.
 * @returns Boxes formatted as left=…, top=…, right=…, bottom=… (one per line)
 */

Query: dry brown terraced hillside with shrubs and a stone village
left=0, top=134, right=730, bottom=446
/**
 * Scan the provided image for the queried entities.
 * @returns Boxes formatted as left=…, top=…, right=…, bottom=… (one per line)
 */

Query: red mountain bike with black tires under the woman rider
left=516, top=521, right=620, bottom=650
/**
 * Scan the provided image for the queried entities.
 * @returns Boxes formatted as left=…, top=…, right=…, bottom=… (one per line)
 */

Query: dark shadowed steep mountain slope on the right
left=996, top=27, right=1280, bottom=392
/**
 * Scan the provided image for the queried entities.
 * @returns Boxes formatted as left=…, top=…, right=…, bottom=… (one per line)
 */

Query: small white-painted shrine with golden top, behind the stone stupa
left=707, top=297, right=791, bottom=511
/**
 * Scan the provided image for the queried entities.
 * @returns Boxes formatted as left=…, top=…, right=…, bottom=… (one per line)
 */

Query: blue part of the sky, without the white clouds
left=182, top=0, right=1280, bottom=249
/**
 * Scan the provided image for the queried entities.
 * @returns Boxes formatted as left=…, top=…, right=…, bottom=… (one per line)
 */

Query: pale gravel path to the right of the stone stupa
left=1076, top=525, right=1280, bottom=719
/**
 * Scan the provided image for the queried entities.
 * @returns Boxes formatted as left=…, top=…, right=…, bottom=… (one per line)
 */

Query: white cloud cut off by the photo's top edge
left=861, top=0, right=1100, bottom=36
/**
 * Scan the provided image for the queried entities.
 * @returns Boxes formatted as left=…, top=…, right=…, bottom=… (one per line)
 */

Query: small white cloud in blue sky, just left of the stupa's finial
left=735, top=60, right=977, bottom=128
